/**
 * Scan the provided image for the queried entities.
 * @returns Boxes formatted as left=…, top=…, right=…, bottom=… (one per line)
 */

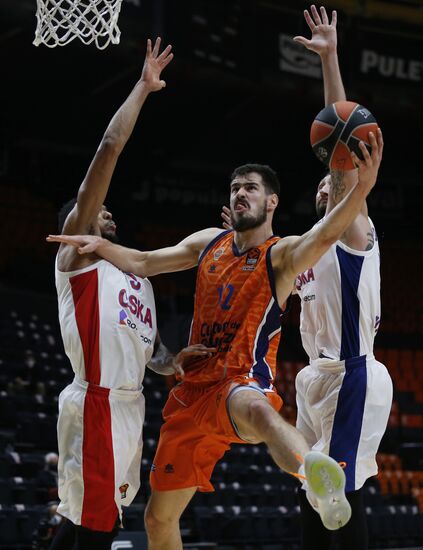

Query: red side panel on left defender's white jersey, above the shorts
left=69, top=269, right=100, bottom=385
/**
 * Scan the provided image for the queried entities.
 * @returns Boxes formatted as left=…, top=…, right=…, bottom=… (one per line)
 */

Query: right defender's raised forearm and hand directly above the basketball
left=294, top=5, right=346, bottom=106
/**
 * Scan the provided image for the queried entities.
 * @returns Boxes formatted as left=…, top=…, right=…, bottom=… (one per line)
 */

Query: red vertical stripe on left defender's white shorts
left=81, top=385, right=118, bottom=531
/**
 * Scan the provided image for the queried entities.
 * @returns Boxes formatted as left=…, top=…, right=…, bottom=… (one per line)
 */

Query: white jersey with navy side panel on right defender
left=296, top=219, right=381, bottom=361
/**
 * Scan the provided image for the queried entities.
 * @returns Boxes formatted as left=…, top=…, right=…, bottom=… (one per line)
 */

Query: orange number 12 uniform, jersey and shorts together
left=151, top=231, right=282, bottom=491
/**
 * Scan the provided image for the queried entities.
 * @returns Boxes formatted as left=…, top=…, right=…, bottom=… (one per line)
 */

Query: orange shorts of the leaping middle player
left=150, top=376, right=282, bottom=492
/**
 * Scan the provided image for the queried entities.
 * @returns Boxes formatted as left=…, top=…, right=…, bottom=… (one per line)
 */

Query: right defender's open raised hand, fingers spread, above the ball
left=294, top=4, right=337, bottom=56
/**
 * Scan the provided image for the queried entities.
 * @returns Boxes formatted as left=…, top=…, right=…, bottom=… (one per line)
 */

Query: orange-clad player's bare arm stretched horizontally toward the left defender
left=47, top=228, right=222, bottom=277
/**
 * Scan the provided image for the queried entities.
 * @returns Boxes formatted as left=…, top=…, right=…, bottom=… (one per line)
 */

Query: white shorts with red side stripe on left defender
left=57, top=378, right=145, bottom=531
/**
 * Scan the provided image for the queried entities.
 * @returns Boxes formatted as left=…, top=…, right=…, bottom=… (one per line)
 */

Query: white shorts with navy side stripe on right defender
left=295, top=355, right=392, bottom=492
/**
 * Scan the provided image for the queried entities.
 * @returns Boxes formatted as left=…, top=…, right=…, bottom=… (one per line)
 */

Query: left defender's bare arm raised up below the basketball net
left=63, top=38, right=173, bottom=235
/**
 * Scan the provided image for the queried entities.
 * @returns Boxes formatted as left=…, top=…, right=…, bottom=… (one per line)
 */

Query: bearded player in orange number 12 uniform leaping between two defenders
left=47, top=127, right=383, bottom=550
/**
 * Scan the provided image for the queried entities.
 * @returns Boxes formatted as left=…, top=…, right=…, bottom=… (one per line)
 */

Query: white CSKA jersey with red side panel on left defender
left=56, top=260, right=157, bottom=390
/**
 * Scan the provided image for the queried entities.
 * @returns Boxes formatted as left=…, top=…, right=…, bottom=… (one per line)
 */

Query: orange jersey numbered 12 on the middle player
left=184, top=231, right=282, bottom=389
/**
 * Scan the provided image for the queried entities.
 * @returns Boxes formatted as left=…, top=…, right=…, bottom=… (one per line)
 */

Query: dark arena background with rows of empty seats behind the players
left=0, top=0, right=423, bottom=550
